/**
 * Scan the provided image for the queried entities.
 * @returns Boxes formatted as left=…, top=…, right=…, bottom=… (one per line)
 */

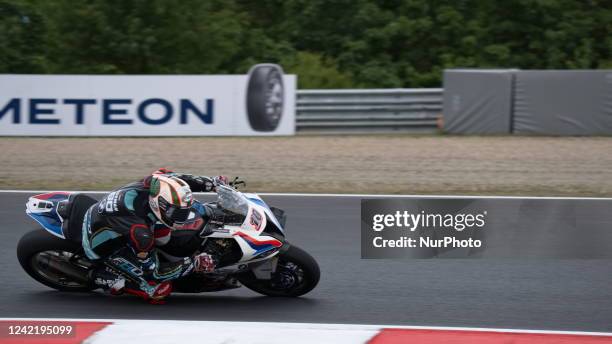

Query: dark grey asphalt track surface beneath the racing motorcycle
left=0, top=193, right=612, bottom=332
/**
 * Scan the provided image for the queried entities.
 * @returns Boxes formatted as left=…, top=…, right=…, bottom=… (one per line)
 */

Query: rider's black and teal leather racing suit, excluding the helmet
left=83, top=169, right=221, bottom=303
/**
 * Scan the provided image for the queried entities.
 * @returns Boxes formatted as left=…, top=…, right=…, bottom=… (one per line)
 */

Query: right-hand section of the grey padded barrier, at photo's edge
left=512, top=70, right=612, bottom=135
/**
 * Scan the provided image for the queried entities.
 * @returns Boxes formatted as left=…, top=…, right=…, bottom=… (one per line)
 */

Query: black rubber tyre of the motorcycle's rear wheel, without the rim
left=17, top=229, right=94, bottom=292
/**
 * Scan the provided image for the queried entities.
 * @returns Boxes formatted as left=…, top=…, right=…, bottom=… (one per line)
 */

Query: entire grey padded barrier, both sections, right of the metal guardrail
left=443, top=69, right=612, bottom=135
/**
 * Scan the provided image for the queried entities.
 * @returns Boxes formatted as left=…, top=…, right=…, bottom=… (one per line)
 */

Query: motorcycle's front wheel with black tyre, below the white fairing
left=238, top=245, right=321, bottom=297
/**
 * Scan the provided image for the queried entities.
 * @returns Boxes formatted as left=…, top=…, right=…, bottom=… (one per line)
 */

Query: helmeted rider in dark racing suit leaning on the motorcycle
left=83, top=169, right=227, bottom=303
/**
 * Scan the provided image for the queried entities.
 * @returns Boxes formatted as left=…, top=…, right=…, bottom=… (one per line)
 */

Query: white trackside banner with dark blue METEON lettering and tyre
left=0, top=65, right=296, bottom=136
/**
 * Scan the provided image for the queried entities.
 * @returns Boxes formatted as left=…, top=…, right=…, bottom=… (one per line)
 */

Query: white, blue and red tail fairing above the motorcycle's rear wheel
left=26, top=191, right=70, bottom=239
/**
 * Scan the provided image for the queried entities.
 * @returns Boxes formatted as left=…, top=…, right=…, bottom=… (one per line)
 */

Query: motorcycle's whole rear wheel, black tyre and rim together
left=17, top=230, right=94, bottom=292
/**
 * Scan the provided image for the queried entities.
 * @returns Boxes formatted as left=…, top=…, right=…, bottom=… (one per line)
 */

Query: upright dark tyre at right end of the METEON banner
left=246, top=63, right=285, bottom=132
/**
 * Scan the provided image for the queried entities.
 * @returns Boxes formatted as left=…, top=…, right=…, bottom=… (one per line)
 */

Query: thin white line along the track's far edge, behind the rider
left=0, top=190, right=612, bottom=201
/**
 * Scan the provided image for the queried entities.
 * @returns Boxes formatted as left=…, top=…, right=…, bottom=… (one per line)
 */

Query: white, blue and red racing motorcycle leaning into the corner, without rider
left=17, top=185, right=320, bottom=297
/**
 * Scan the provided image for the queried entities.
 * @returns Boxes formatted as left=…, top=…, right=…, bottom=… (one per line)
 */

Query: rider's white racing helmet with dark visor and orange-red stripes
left=149, top=175, right=193, bottom=227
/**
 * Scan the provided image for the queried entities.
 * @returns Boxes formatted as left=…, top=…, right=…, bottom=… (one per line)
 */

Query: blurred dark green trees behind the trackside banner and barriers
left=0, top=0, right=612, bottom=88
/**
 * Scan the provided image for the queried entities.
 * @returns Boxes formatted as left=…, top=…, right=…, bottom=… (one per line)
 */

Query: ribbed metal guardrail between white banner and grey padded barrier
left=297, top=88, right=442, bottom=134
